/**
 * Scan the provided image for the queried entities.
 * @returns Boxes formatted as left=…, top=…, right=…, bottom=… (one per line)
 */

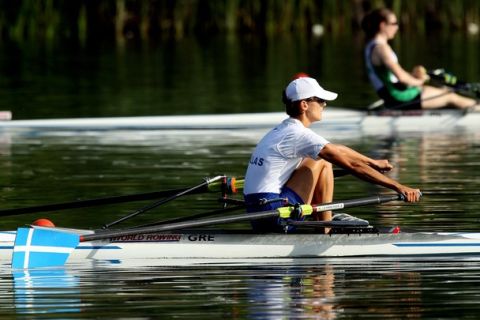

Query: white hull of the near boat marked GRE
left=0, top=230, right=480, bottom=263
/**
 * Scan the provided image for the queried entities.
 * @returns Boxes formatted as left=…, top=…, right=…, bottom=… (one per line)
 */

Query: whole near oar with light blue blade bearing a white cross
left=12, top=194, right=403, bottom=268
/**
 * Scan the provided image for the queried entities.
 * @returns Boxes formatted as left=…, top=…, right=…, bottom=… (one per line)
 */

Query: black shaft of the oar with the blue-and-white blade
left=80, top=195, right=402, bottom=242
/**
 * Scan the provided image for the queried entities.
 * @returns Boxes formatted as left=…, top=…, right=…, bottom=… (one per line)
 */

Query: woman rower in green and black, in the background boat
left=362, top=8, right=478, bottom=110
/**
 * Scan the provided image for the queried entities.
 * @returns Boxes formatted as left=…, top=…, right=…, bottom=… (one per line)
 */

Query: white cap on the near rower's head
left=285, top=77, right=338, bottom=102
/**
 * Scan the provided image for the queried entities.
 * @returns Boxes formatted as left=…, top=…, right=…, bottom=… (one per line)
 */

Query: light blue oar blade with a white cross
left=12, top=228, right=80, bottom=269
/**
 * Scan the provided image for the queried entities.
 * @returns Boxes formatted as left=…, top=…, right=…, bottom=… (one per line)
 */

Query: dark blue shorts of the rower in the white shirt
left=244, top=187, right=304, bottom=232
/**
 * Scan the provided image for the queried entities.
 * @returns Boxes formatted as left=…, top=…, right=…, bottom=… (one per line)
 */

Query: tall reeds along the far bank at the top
left=0, top=0, right=480, bottom=41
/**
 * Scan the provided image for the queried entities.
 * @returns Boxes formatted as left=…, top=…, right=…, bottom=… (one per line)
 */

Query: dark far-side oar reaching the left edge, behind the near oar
left=0, top=175, right=243, bottom=216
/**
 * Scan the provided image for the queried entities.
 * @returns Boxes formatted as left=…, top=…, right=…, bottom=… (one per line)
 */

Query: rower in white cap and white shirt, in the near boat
left=244, top=77, right=420, bottom=232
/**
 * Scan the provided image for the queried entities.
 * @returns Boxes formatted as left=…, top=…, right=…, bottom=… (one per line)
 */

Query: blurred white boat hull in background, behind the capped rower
left=0, top=107, right=480, bottom=133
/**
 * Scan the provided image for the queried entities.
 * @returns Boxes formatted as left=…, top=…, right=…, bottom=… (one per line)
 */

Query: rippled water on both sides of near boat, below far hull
left=0, top=131, right=480, bottom=319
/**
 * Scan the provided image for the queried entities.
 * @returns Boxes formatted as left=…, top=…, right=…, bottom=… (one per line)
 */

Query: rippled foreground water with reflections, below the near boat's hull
left=0, top=257, right=480, bottom=319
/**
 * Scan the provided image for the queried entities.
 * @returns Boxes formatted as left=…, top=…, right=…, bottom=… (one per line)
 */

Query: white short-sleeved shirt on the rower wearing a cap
left=244, top=118, right=329, bottom=195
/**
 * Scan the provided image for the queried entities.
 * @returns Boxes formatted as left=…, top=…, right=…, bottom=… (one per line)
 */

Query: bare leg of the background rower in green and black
left=422, top=86, right=478, bottom=109
